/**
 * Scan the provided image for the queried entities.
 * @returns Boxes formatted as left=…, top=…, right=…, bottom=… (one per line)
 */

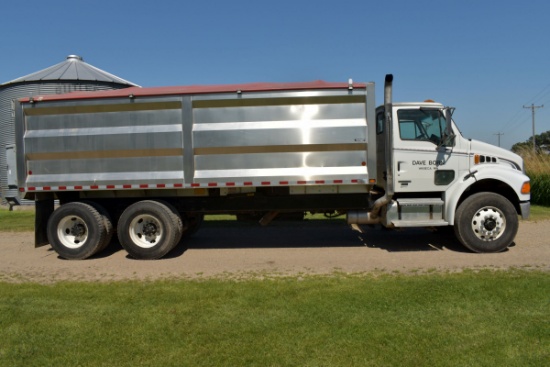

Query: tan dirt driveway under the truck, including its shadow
left=0, top=221, right=550, bottom=283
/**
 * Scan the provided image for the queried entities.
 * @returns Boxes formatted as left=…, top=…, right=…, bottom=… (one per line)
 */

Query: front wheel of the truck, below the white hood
left=454, top=192, right=519, bottom=252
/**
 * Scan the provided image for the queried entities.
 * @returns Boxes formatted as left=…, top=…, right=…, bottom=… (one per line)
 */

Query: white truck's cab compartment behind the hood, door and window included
left=376, top=102, right=467, bottom=193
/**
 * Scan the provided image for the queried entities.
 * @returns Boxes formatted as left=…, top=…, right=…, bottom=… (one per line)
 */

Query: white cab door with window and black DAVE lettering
left=393, top=107, right=459, bottom=192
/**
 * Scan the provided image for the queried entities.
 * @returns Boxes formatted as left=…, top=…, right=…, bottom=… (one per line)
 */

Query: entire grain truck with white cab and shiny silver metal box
left=8, top=75, right=530, bottom=259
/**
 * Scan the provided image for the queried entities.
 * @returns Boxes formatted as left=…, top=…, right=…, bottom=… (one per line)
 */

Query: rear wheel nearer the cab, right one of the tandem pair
left=117, top=200, right=183, bottom=260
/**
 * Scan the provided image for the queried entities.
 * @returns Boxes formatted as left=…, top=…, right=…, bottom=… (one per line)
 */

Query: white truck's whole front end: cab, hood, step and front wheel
left=364, top=87, right=530, bottom=252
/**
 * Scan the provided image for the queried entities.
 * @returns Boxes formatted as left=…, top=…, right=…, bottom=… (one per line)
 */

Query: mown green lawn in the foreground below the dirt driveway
left=0, top=270, right=550, bottom=367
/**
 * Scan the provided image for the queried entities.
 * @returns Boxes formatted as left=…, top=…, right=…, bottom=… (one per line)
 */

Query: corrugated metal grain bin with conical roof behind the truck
left=0, top=55, right=137, bottom=203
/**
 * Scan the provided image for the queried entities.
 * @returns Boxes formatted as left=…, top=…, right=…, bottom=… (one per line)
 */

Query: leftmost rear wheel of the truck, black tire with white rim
left=47, top=202, right=109, bottom=260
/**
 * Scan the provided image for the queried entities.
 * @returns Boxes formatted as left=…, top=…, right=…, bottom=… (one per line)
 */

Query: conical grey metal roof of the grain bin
left=1, top=55, right=137, bottom=86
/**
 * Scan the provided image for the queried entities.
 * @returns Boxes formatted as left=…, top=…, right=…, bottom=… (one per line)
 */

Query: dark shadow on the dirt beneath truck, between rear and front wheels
left=166, top=220, right=470, bottom=258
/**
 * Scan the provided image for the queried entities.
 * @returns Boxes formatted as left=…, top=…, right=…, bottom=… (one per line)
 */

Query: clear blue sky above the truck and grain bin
left=0, top=0, right=550, bottom=149
